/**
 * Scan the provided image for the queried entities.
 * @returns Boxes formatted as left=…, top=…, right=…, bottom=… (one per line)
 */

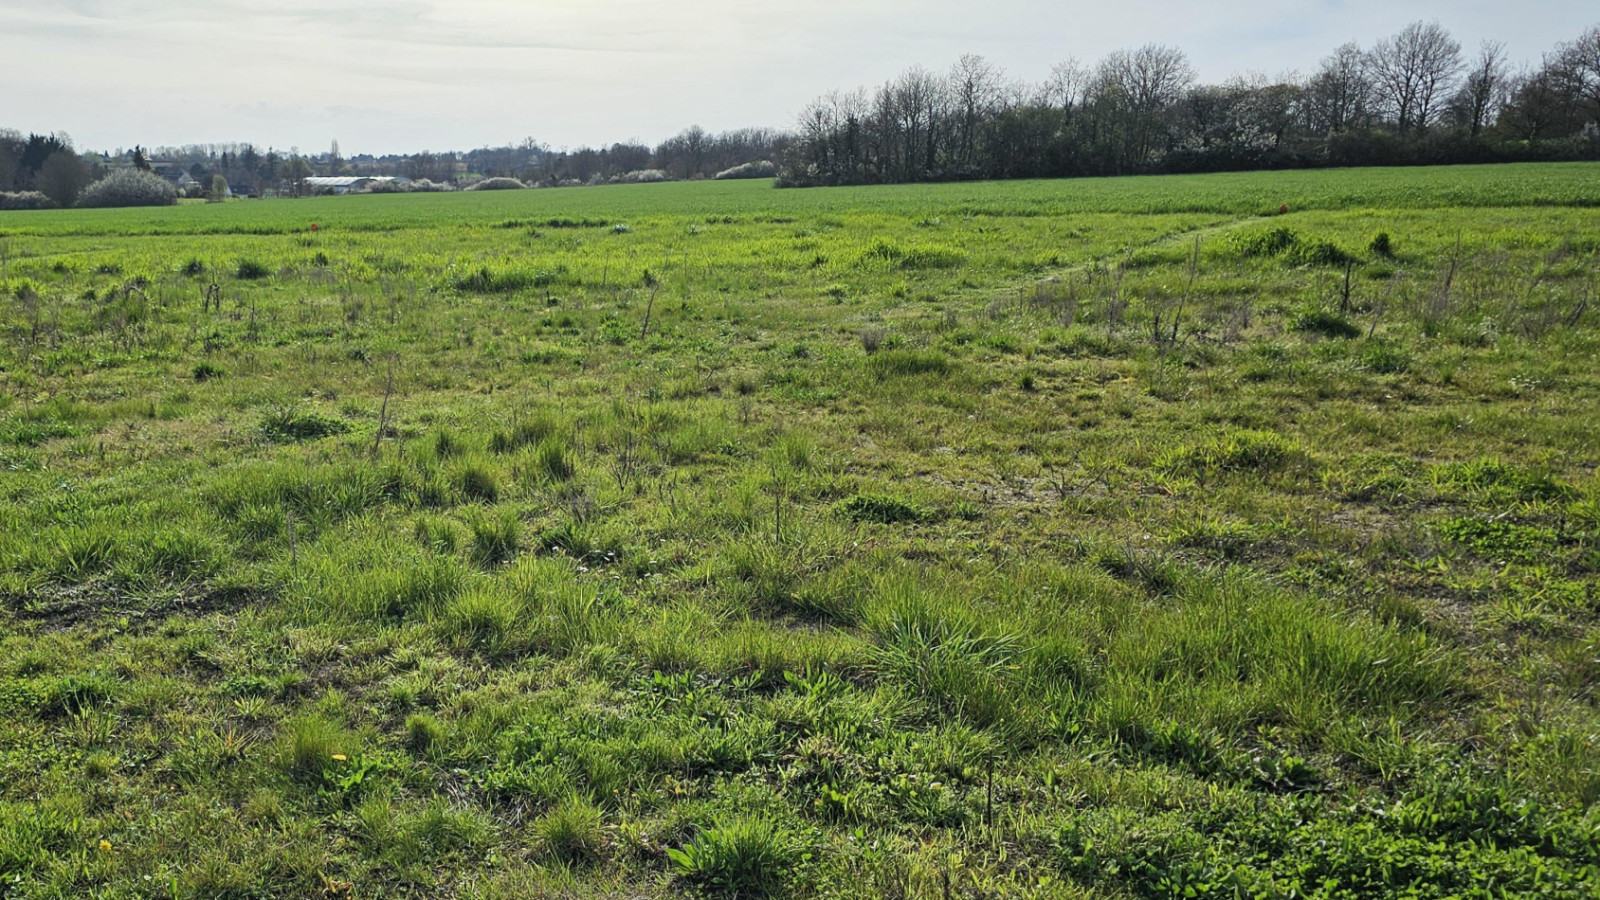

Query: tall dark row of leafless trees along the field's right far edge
left=781, top=21, right=1600, bottom=186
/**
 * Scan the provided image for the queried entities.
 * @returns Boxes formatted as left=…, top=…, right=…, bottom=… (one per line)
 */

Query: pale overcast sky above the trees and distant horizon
left=0, top=0, right=1600, bottom=155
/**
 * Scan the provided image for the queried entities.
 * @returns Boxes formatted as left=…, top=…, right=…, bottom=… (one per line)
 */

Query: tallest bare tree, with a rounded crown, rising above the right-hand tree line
left=1368, top=21, right=1461, bottom=135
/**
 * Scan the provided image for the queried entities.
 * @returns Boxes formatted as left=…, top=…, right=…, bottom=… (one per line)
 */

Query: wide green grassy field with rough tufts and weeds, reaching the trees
left=0, top=163, right=1600, bottom=900
